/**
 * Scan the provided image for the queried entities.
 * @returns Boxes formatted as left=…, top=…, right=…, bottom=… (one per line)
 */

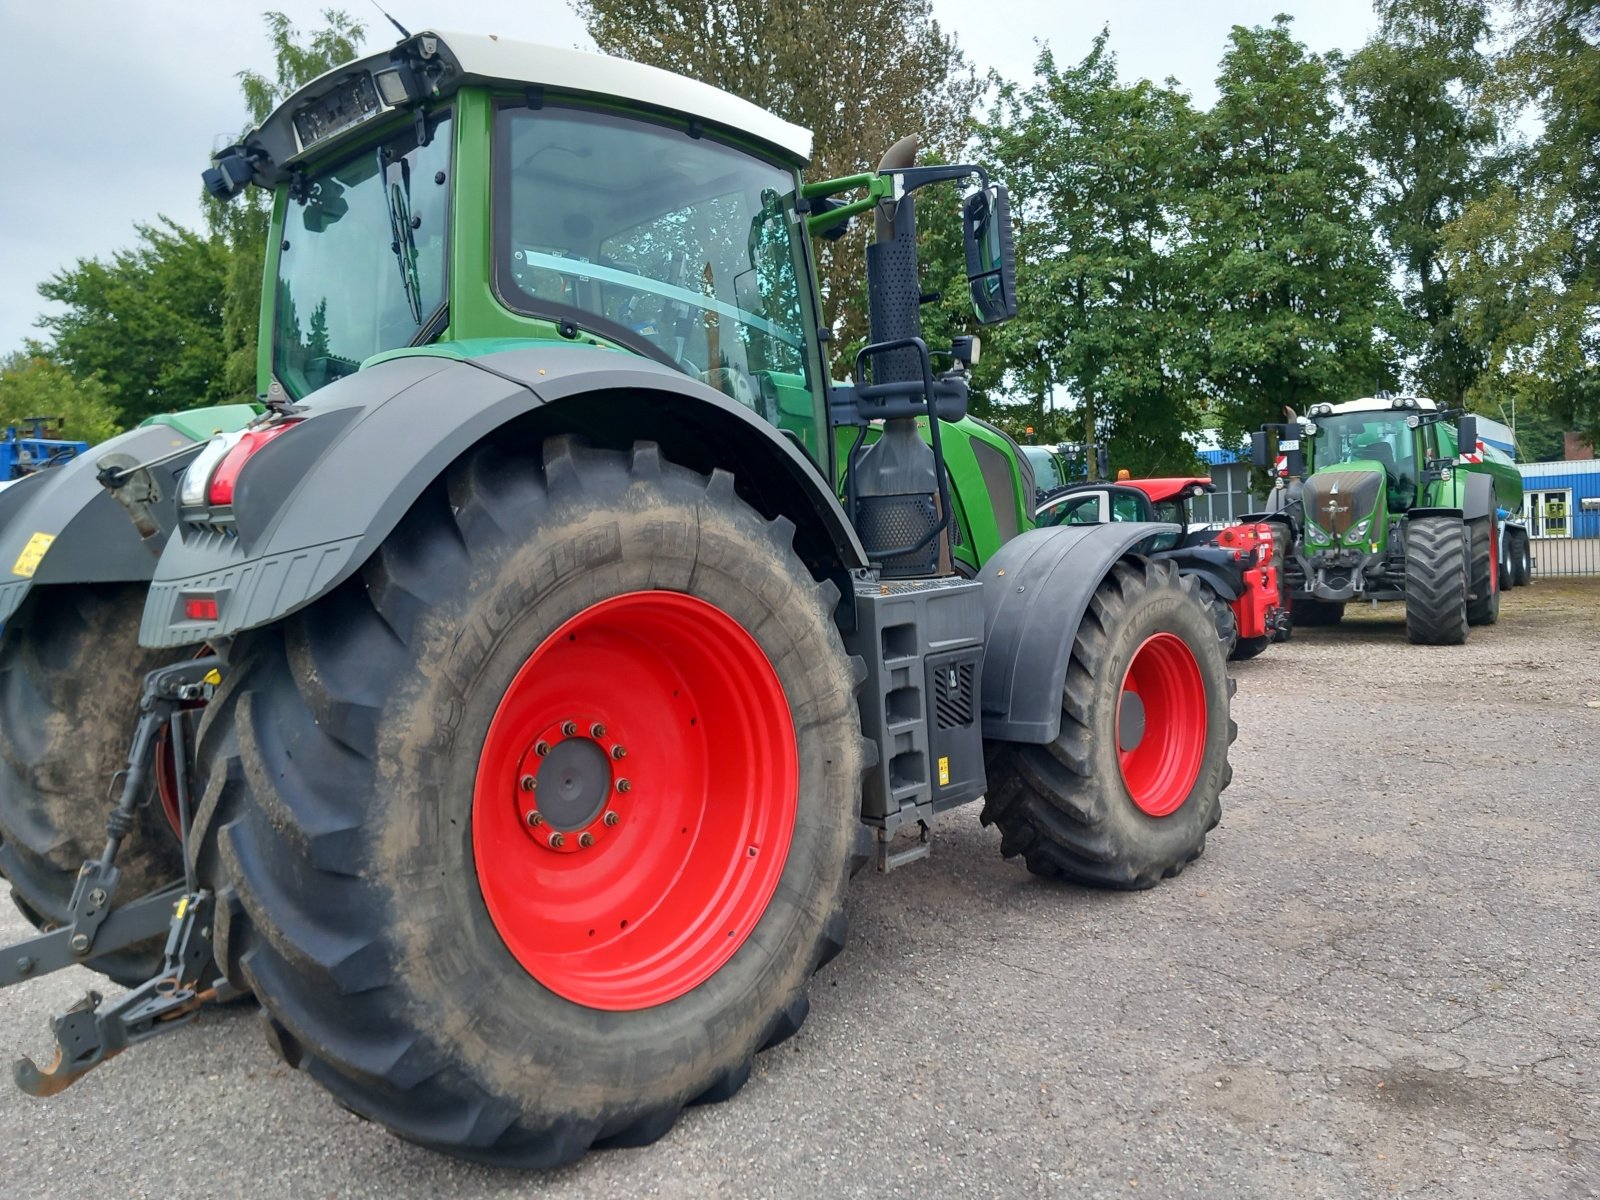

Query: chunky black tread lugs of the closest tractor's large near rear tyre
left=192, top=437, right=864, bottom=1168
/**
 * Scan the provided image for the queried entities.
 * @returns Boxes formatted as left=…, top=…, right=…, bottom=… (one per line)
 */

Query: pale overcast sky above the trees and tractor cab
left=0, top=0, right=1373, bottom=354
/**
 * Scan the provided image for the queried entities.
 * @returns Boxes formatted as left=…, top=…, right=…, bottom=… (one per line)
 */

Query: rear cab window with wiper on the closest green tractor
left=272, top=114, right=450, bottom=398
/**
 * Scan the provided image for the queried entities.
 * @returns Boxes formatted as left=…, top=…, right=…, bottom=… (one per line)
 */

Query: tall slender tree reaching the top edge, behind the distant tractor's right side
left=1344, top=0, right=1506, bottom=405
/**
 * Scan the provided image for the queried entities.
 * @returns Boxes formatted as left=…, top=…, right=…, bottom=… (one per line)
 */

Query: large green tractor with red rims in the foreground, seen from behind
left=0, top=32, right=1234, bottom=1166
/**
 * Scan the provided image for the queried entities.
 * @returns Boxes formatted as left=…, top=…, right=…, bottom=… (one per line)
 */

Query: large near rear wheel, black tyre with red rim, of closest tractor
left=188, top=438, right=862, bottom=1166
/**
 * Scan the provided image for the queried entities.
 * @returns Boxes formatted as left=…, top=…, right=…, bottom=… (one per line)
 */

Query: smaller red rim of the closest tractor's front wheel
left=1117, top=634, right=1208, bottom=816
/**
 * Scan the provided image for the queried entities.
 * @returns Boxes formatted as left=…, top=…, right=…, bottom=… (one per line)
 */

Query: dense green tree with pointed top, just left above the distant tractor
left=1189, top=16, right=1398, bottom=443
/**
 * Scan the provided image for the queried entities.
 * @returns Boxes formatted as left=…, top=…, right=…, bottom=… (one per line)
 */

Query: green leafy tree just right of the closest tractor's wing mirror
left=979, top=32, right=1198, bottom=474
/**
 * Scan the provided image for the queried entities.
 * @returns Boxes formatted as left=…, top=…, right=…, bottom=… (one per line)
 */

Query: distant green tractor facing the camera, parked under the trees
left=1246, top=394, right=1528, bottom=645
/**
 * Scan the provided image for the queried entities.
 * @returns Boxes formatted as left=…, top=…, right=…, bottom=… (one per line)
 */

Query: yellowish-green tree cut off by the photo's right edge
left=1445, top=0, right=1600, bottom=438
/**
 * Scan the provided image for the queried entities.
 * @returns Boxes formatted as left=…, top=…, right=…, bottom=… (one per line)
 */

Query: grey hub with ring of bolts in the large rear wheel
left=514, top=718, right=632, bottom=854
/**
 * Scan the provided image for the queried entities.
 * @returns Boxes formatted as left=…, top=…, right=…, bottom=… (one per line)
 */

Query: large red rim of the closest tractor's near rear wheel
left=472, top=592, right=800, bottom=1011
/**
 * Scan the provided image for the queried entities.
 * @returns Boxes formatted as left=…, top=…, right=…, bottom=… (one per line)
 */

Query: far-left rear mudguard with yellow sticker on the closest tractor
left=0, top=426, right=200, bottom=621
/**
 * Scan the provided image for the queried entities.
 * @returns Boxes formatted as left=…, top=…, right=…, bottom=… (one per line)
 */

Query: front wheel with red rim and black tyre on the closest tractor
left=982, top=560, right=1237, bottom=888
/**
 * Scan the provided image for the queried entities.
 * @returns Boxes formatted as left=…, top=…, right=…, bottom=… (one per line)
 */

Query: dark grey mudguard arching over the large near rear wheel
left=139, top=346, right=866, bottom=648
